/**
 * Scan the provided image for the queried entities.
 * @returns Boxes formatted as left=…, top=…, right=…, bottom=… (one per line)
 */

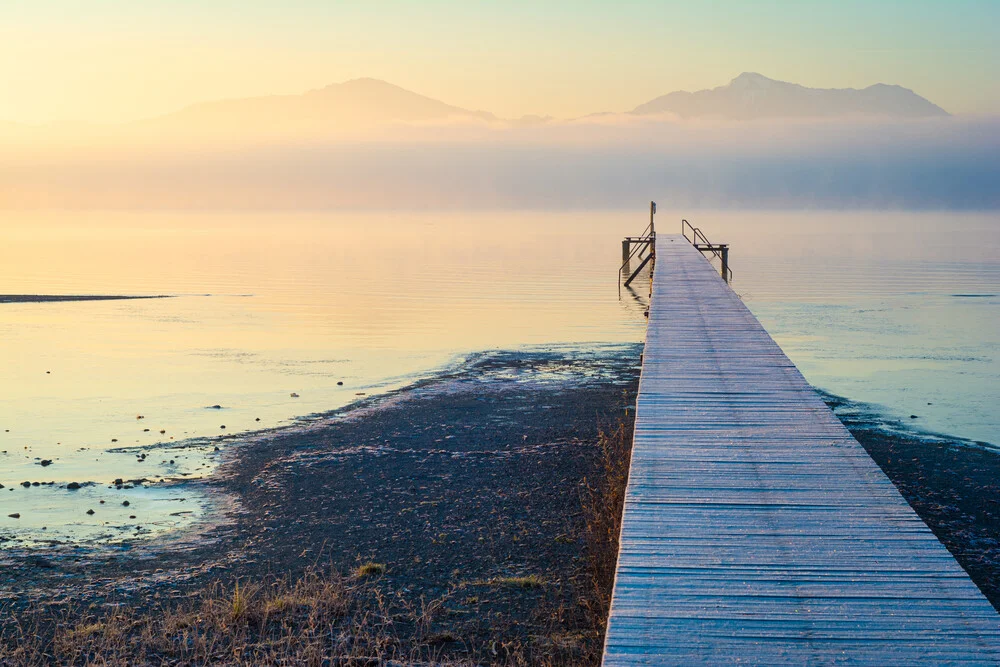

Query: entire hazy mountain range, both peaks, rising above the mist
left=0, top=72, right=950, bottom=138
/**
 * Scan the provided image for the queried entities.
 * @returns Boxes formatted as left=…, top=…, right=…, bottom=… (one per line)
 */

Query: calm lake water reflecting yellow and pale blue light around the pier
left=0, top=208, right=1000, bottom=546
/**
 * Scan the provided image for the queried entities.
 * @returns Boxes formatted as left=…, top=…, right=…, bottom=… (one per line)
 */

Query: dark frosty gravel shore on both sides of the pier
left=0, top=345, right=1000, bottom=664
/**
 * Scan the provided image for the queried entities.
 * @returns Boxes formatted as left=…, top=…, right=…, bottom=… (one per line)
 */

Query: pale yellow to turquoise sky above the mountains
left=0, top=0, right=1000, bottom=122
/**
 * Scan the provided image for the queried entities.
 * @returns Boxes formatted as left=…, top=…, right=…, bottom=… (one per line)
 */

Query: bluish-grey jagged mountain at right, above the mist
left=631, top=72, right=949, bottom=120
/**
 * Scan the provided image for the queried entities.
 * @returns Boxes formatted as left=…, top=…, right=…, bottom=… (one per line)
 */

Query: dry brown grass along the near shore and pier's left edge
left=0, top=414, right=632, bottom=667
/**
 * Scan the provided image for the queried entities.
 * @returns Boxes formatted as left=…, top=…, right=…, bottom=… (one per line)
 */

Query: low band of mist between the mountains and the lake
left=0, top=114, right=1000, bottom=209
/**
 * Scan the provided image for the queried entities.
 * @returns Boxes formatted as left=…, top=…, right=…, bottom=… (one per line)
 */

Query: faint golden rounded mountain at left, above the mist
left=133, top=78, right=496, bottom=135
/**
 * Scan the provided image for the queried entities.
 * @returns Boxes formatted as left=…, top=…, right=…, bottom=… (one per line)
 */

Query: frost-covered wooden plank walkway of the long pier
left=604, top=235, right=1000, bottom=667
